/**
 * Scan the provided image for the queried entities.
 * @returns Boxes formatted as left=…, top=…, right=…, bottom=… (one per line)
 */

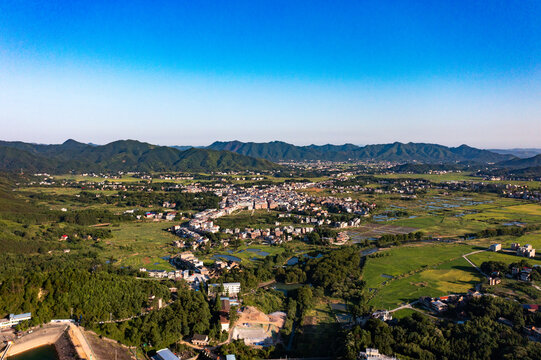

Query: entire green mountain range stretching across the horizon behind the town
left=0, top=139, right=541, bottom=173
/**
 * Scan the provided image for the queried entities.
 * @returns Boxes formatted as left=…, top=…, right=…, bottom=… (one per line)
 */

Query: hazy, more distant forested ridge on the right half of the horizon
left=208, top=141, right=515, bottom=163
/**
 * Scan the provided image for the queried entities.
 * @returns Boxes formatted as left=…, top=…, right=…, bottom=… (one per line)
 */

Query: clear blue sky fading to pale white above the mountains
left=0, top=0, right=541, bottom=147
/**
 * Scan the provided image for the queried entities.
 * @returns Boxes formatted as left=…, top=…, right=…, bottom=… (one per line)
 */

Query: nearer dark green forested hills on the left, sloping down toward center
left=0, top=140, right=279, bottom=173
